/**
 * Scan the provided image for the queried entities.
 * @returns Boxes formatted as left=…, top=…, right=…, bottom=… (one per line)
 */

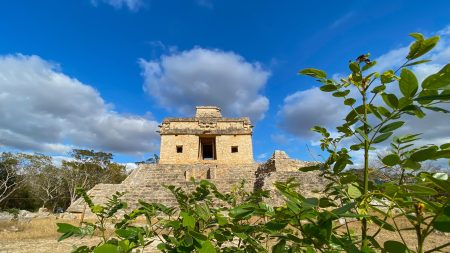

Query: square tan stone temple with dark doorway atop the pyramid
left=159, top=106, right=254, bottom=164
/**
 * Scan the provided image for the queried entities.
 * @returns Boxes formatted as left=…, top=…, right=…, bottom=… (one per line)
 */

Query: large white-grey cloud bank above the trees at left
left=0, top=55, right=158, bottom=154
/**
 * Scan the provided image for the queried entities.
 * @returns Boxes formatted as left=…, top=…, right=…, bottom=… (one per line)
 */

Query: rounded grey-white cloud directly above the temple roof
left=139, top=48, right=270, bottom=120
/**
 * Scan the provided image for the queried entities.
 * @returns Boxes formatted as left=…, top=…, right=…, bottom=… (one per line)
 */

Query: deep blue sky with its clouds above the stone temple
left=0, top=0, right=450, bottom=162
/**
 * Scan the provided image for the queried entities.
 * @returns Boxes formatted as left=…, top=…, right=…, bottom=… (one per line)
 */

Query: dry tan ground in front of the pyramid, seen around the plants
left=0, top=218, right=450, bottom=253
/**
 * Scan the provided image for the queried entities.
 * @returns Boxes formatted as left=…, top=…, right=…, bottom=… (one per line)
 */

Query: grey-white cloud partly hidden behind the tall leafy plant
left=278, top=26, right=450, bottom=148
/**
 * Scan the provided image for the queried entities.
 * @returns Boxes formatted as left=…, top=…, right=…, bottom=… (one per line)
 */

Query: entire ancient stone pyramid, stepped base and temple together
left=68, top=106, right=325, bottom=213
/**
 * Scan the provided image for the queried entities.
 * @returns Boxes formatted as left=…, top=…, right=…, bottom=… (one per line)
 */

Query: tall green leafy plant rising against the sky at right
left=300, top=33, right=450, bottom=253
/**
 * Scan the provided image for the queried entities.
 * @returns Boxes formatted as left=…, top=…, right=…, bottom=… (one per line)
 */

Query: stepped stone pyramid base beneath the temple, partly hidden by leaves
left=68, top=151, right=327, bottom=212
